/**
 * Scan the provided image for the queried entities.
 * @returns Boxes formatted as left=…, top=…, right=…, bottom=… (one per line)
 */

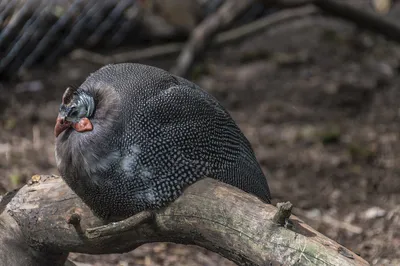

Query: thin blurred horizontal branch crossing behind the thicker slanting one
left=70, top=6, right=319, bottom=65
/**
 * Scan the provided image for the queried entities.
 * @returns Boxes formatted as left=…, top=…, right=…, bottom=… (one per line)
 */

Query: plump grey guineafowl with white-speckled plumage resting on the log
left=54, top=63, right=271, bottom=221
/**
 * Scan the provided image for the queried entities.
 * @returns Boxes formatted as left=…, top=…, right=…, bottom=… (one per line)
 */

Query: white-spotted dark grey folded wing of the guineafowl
left=131, top=82, right=269, bottom=204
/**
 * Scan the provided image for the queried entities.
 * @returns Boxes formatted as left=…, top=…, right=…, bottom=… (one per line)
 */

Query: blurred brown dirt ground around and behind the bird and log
left=0, top=14, right=400, bottom=266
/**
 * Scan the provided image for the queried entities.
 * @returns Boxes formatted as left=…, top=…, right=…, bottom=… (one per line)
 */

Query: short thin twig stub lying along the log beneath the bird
left=85, top=211, right=154, bottom=238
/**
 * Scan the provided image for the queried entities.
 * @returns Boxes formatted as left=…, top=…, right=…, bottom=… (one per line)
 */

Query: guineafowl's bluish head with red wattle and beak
left=54, top=87, right=95, bottom=137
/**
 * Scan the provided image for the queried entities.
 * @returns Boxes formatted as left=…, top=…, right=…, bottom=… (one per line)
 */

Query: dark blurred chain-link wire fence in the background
left=0, top=0, right=268, bottom=79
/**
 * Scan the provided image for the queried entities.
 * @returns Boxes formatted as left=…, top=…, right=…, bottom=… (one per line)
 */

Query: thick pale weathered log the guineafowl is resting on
left=0, top=175, right=368, bottom=266
